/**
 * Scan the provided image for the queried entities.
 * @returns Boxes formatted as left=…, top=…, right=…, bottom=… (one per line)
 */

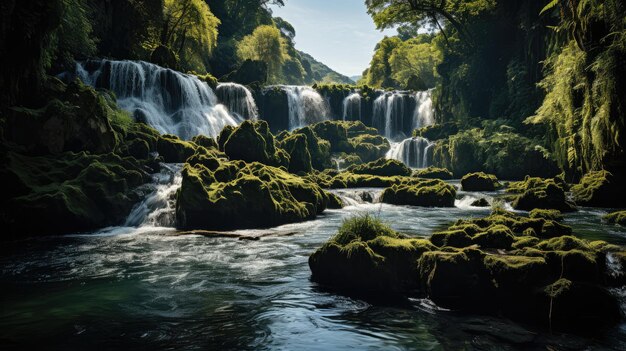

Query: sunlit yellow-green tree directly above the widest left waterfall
left=160, top=0, right=220, bottom=73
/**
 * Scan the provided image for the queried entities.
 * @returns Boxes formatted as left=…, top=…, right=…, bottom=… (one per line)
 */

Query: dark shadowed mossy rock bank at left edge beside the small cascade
left=0, top=152, right=150, bottom=239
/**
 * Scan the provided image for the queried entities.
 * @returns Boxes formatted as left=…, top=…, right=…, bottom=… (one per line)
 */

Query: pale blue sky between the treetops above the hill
left=272, top=0, right=396, bottom=76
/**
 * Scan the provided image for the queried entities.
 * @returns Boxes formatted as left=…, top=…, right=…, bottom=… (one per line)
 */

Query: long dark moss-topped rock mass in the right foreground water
left=309, top=210, right=626, bottom=332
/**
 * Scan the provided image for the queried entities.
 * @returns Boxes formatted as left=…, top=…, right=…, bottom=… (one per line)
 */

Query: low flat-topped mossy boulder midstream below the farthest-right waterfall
left=380, top=179, right=456, bottom=207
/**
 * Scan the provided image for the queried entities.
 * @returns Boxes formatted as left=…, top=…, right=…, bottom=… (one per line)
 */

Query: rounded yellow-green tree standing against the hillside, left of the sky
left=237, top=25, right=289, bottom=82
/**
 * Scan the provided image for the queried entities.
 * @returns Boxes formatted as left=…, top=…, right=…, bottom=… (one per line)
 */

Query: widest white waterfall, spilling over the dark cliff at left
left=76, top=60, right=242, bottom=139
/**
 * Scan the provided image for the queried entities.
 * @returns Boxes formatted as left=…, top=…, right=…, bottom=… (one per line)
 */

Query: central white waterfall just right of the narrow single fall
left=268, top=85, right=330, bottom=130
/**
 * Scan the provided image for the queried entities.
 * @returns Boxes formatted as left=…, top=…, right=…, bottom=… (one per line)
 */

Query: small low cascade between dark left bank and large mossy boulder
left=124, top=163, right=183, bottom=227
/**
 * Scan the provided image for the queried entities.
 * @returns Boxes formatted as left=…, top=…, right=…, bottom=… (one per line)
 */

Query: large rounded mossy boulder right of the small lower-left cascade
left=176, top=160, right=328, bottom=230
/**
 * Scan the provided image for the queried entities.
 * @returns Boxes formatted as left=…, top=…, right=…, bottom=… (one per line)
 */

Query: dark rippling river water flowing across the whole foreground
left=0, top=186, right=626, bottom=350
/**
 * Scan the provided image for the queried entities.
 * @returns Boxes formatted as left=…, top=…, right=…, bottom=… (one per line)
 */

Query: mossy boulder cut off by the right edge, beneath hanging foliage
left=571, top=171, right=626, bottom=207
